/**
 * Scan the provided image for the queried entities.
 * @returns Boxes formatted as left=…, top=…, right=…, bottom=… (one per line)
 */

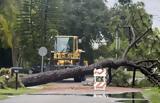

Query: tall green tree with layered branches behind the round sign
left=17, top=0, right=61, bottom=67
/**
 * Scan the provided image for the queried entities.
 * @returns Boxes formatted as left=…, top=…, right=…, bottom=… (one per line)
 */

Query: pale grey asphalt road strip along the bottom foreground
left=0, top=95, right=116, bottom=103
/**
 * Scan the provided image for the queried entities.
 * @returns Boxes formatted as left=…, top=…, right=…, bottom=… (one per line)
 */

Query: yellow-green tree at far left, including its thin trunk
left=0, top=0, right=21, bottom=64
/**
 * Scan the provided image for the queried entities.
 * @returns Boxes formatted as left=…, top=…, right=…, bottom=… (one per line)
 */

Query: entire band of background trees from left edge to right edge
left=0, top=0, right=160, bottom=66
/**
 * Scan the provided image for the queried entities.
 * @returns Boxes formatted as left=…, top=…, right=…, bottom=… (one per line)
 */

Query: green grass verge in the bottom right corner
left=142, top=87, right=160, bottom=103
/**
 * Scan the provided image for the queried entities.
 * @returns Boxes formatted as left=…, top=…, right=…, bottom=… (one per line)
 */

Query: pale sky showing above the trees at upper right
left=108, top=0, right=160, bottom=28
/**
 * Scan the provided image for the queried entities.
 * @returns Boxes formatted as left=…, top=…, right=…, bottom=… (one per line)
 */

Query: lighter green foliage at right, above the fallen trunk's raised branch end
left=94, top=0, right=160, bottom=60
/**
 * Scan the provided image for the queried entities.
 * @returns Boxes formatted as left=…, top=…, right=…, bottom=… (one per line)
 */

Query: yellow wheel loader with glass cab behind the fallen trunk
left=51, top=36, right=87, bottom=82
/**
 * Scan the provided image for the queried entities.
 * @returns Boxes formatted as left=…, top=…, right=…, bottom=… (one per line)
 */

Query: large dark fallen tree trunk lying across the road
left=21, top=59, right=160, bottom=86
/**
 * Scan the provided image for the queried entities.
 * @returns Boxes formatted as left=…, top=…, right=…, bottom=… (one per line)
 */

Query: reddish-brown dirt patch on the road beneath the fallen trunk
left=38, top=82, right=142, bottom=94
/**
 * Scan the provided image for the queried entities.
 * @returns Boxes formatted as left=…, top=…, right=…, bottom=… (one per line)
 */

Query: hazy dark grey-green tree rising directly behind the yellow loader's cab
left=59, top=0, right=108, bottom=63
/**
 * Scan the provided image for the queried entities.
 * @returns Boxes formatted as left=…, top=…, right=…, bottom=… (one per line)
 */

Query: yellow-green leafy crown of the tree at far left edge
left=0, top=0, right=17, bottom=47
